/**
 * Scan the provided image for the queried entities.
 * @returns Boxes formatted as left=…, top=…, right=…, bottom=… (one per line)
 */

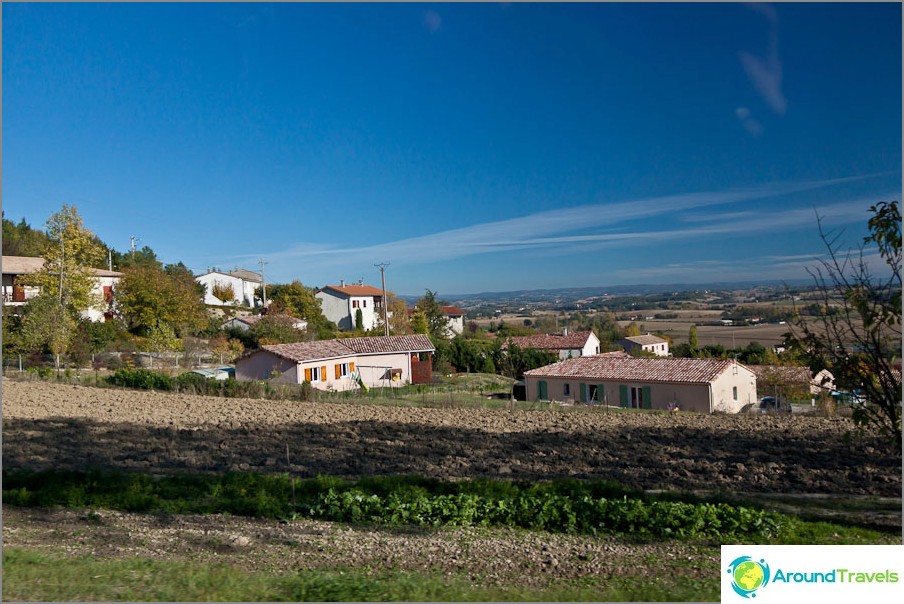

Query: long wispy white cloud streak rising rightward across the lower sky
left=248, top=177, right=880, bottom=278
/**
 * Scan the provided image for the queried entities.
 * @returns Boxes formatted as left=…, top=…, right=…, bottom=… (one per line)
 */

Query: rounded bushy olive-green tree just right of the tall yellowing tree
left=116, top=265, right=207, bottom=336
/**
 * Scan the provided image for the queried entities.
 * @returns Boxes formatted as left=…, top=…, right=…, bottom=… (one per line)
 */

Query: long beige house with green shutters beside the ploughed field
left=524, top=355, right=757, bottom=413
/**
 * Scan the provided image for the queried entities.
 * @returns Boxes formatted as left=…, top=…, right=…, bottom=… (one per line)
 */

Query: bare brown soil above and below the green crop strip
left=3, top=379, right=901, bottom=586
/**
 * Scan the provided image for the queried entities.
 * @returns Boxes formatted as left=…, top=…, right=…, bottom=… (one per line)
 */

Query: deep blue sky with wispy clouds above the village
left=2, top=2, right=902, bottom=296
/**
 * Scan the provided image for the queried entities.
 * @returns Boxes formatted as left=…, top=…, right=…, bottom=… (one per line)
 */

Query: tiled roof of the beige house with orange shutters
left=243, top=334, right=434, bottom=363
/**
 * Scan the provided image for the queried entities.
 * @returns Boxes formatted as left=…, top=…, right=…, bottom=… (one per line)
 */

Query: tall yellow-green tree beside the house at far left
left=22, top=205, right=104, bottom=311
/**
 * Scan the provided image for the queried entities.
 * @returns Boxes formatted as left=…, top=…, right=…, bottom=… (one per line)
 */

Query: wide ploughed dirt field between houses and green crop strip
left=3, top=379, right=901, bottom=497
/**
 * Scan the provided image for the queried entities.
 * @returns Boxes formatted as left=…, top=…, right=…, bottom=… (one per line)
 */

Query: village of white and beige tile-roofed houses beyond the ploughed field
left=2, top=210, right=854, bottom=414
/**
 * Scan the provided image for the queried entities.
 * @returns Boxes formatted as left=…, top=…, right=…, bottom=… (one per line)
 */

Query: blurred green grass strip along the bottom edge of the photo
left=3, top=548, right=719, bottom=602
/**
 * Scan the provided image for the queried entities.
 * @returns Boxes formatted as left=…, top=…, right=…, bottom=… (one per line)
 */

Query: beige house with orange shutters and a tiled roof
left=235, top=334, right=435, bottom=391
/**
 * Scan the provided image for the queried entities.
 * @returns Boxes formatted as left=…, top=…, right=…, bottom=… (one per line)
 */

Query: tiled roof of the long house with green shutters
left=524, top=355, right=743, bottom=384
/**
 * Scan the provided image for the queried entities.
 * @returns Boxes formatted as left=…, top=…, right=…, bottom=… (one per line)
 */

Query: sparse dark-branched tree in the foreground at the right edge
left=789, top=201, right=901, bottom=454
